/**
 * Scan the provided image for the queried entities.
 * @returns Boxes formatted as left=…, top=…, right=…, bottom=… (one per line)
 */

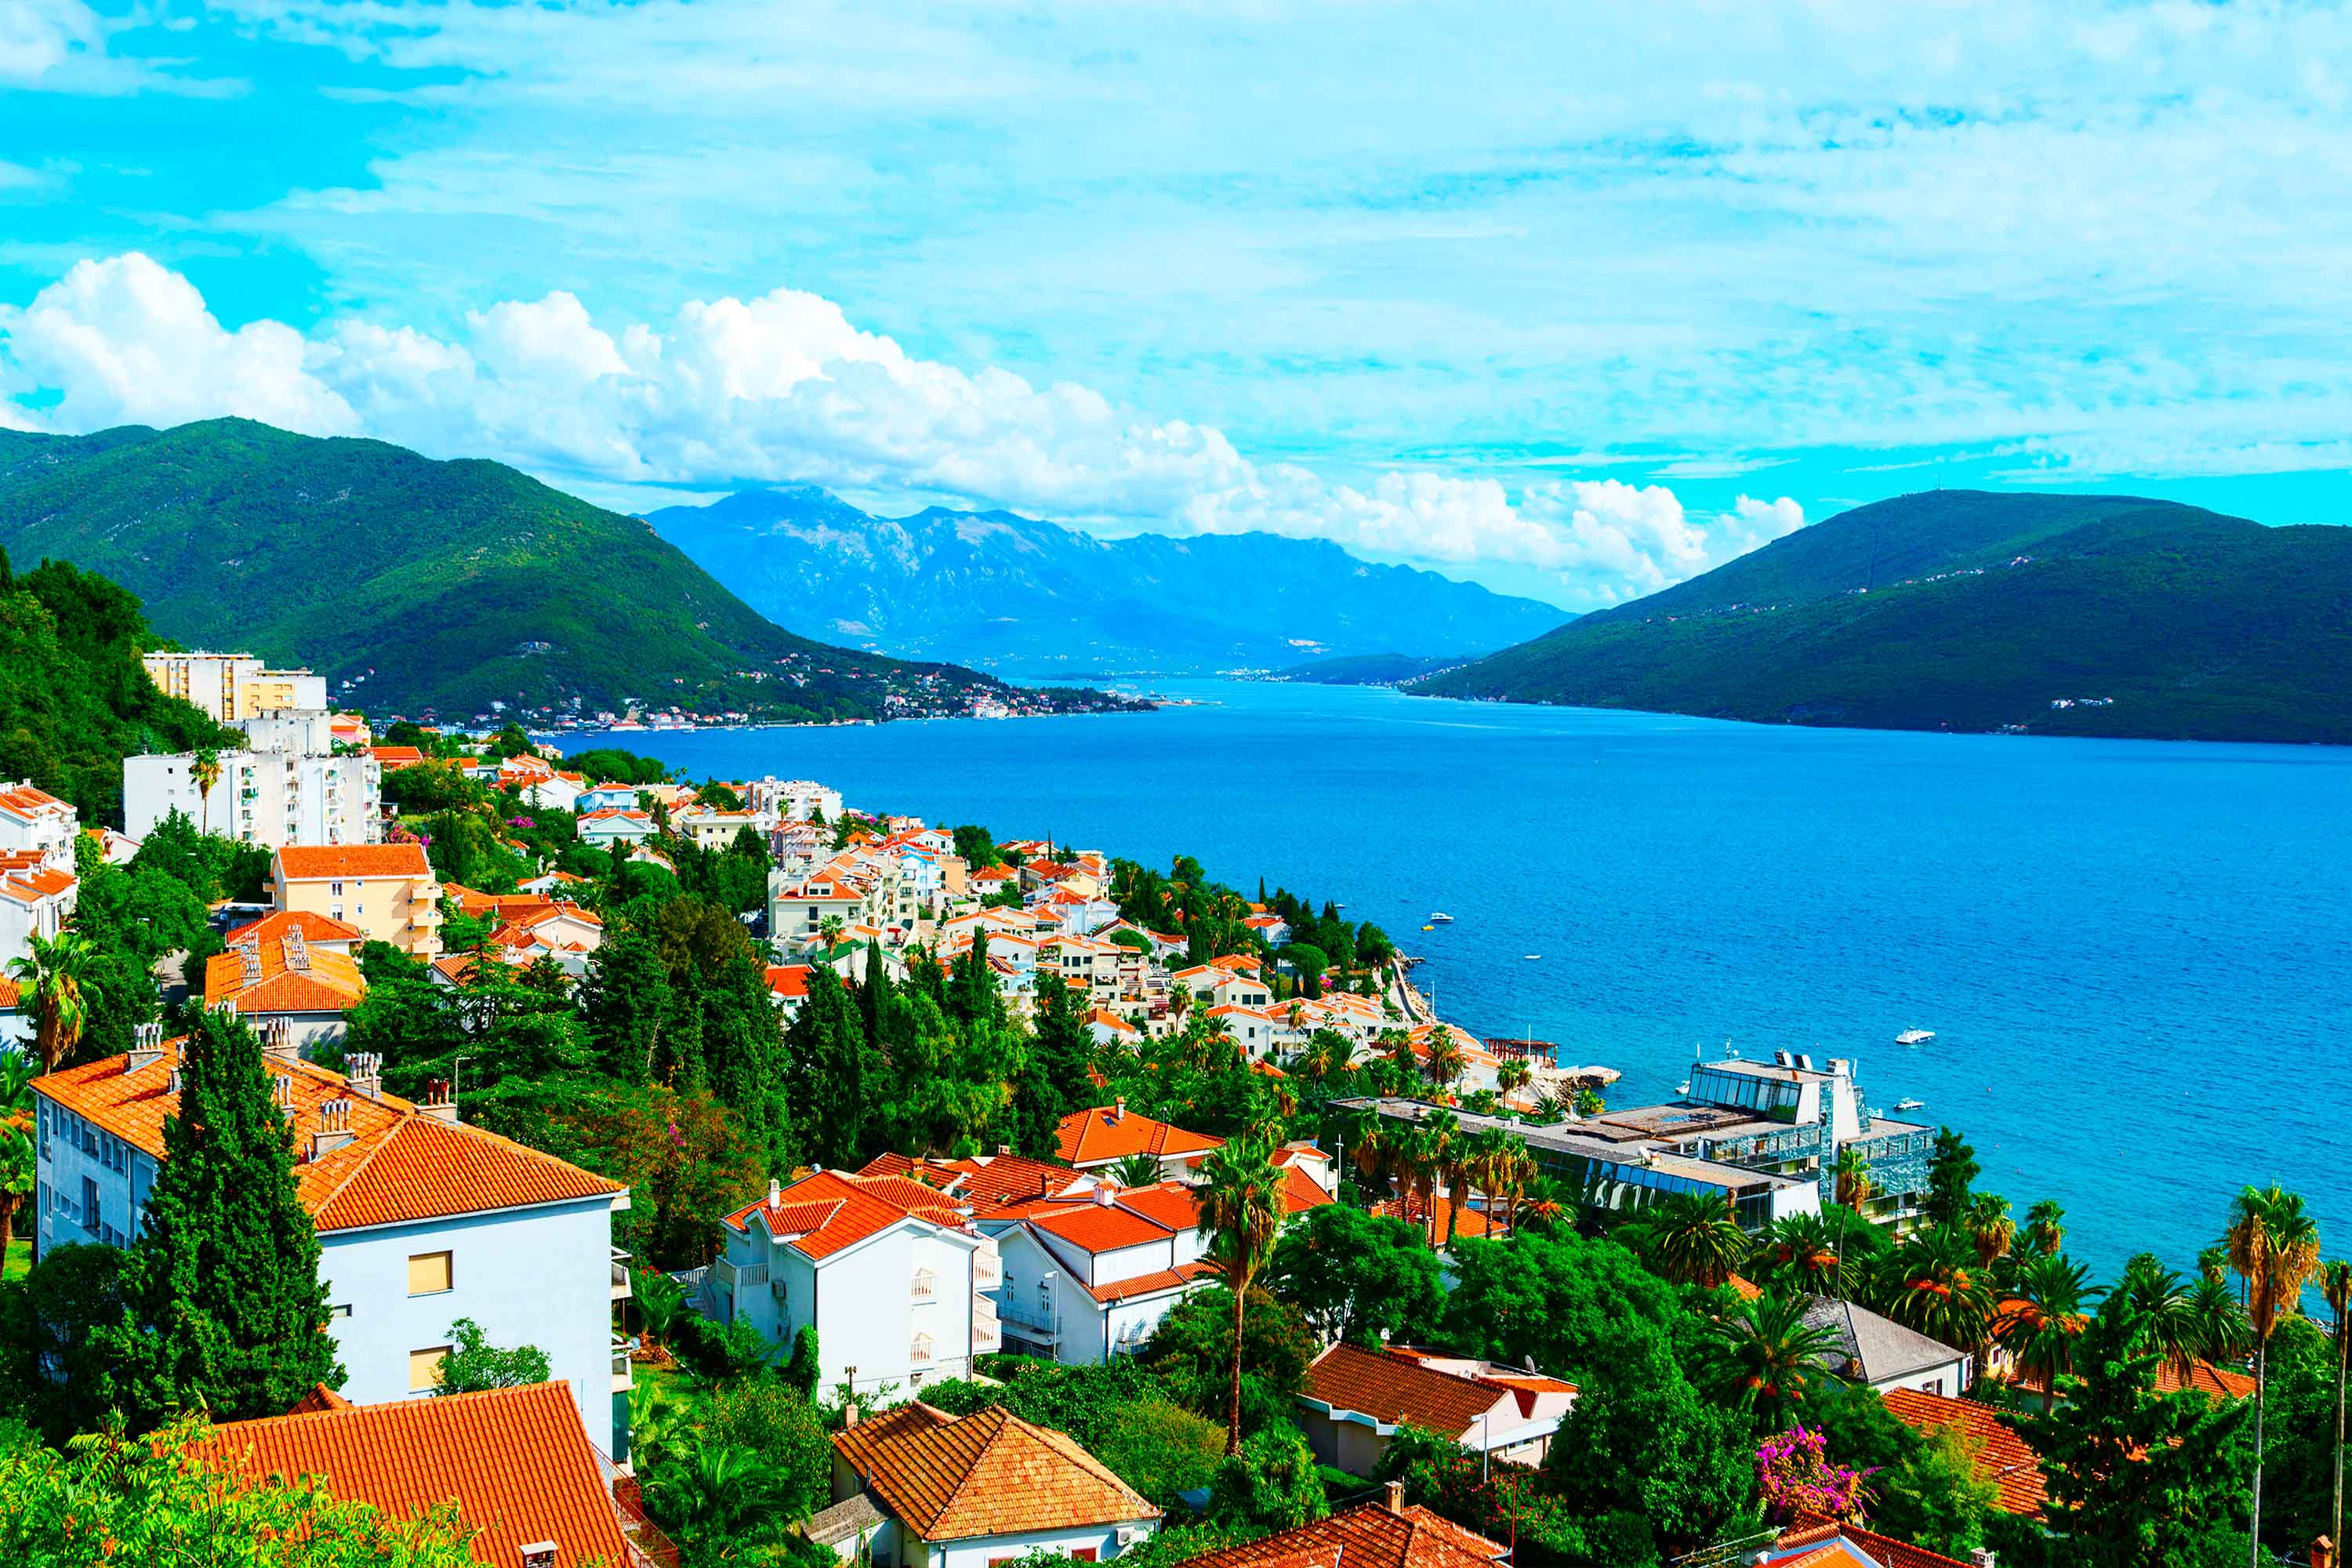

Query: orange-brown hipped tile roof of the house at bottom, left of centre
left=833, top=1403, right=1160, bottom=1540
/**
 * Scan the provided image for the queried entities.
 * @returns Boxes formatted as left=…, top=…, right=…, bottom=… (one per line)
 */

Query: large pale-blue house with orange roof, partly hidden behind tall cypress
left=31, top=1025, right=630, bottom=1460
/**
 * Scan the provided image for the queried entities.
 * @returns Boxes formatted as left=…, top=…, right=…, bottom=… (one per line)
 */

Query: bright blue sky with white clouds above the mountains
left=0, top=0, right=2352, bottom=607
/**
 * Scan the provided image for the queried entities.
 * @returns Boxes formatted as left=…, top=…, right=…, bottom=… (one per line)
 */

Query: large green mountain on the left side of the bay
left=0, top=419, right=1129, bottom=720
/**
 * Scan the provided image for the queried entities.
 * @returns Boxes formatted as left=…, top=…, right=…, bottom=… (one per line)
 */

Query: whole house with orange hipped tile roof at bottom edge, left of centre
left=823, top=1401, right=1160, bottom=1568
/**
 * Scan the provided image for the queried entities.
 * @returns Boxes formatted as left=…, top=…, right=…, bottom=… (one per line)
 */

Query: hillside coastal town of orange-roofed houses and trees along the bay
left=0, top=652, right=2352, bottom=1568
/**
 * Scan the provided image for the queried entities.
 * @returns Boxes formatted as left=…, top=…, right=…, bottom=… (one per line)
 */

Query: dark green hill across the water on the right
left=1414, top=492, right=2352, bottom=743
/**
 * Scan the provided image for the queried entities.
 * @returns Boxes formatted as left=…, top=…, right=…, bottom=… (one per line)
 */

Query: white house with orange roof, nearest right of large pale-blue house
left=703, top=1171, right=1002, bottom=1399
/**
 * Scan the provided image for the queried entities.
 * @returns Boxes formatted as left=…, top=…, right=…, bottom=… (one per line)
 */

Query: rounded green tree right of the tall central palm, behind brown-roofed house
left=1265, top=1203, right=1446, bottom=1347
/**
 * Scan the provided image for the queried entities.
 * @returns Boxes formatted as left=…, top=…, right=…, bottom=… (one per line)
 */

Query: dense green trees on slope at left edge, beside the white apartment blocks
left=0, top=550, right=238, bottom=827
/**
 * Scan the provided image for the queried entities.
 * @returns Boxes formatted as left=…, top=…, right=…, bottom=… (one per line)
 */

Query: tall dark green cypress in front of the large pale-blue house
left=103, top=1011, right=343, bottom=1425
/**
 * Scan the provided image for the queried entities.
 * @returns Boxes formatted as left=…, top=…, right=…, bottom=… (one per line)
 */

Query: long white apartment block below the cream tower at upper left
left=122, top=750, right=383, bottom=848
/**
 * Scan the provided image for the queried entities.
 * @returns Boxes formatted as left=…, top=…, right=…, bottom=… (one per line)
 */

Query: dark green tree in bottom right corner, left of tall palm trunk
left=2018, top=1290, right=2253, bottom=1568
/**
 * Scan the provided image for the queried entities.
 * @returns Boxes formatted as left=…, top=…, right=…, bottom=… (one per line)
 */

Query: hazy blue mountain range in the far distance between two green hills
left=647, top=487, right=1566, bottom=673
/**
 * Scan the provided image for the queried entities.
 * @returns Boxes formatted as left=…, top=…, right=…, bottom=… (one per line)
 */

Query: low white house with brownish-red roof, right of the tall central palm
left=1298, top=1342, right=1576, bottom=1476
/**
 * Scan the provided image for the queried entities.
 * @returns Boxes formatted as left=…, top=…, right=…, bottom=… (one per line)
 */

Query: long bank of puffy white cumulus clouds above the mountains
left=0, top=252, right=1804, bottom=602
